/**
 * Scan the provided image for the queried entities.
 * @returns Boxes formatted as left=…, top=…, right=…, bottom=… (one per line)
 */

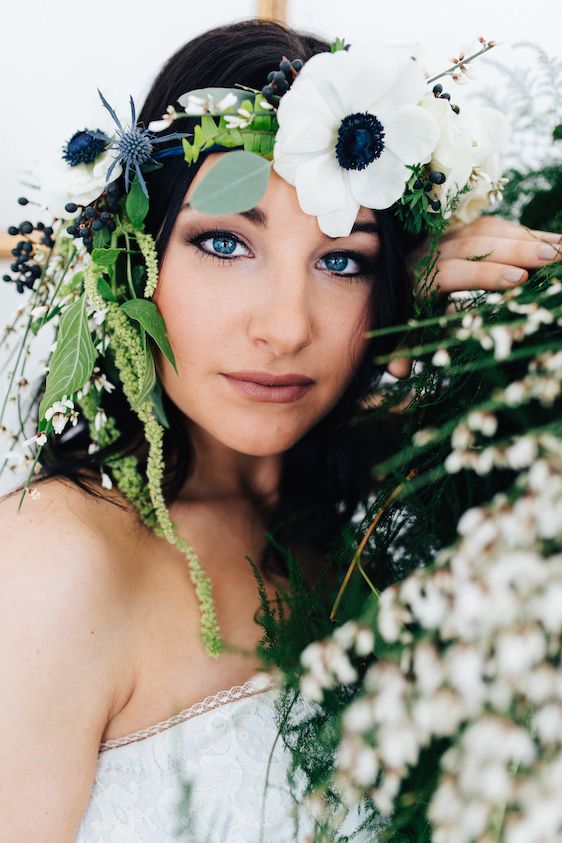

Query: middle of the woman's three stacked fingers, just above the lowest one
left=439, top=235, right=562, bottom=269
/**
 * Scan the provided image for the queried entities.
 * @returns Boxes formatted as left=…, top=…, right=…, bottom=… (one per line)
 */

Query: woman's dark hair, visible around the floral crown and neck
left=32, top=19, right=420, bottom=571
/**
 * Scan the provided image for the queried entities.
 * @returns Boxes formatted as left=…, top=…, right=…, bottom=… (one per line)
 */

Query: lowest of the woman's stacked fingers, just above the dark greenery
left=424, top=259, right=529, bottom=295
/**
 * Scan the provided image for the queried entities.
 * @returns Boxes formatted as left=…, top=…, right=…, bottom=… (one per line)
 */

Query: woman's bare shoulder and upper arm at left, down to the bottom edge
left=0, top=479, right=142, bottom=843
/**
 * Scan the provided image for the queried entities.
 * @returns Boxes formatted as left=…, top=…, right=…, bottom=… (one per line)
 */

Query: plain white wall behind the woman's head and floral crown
left=0, top=0, right=562, bottom=492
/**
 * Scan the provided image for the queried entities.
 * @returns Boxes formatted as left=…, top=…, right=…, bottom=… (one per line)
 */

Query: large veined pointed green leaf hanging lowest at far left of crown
left=39, top=295, right=96, bottom=419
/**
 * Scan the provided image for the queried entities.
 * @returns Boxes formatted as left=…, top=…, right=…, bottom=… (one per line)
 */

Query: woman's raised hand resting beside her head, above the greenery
left=387, top=216, right=562, bottom=378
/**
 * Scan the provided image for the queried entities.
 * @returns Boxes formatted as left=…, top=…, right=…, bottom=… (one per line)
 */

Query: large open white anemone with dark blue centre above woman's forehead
left=273, top=44, right=439, bottom=237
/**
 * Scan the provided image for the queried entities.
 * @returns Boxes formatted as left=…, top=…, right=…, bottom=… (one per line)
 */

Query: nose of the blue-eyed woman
left=248, top=263, right=313, bottom=357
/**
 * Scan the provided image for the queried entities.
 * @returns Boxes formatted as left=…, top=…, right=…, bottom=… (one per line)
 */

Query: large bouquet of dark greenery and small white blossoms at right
left=253, top=120, right=562, bottom=843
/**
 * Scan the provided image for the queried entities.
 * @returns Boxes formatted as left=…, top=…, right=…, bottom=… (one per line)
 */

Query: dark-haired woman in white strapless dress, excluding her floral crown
left=0, top=13, right=547, bottom=843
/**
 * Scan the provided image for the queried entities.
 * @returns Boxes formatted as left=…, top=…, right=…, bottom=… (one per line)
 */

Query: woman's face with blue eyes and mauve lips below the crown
left=154, top=152, right=379, bottom=456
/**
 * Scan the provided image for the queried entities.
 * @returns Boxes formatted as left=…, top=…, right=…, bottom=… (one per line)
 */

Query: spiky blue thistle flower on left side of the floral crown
left=88, top=88, right=187, bottom=197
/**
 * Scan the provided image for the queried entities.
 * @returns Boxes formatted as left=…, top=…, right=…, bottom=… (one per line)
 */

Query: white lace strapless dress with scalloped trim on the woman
left=71, top=675, right=375, bottom=843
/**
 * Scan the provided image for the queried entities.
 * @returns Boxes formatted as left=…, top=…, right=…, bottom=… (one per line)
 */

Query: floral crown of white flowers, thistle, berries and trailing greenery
left=0, top=38, right=507, bottom=655
